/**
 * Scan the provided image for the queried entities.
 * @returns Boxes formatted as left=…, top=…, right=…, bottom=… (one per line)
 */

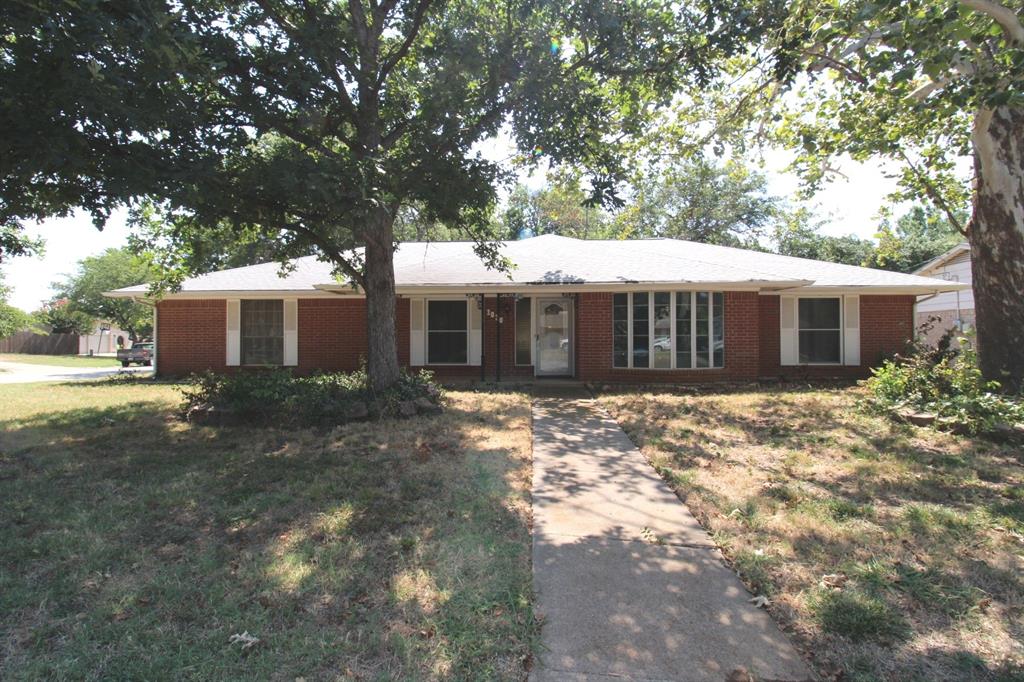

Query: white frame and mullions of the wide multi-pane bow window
left=611, top=289, right=725, bottom=372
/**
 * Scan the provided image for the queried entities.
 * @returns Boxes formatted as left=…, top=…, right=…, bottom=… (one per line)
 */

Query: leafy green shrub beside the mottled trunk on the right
left=864, top=329, right=1024, bottom=433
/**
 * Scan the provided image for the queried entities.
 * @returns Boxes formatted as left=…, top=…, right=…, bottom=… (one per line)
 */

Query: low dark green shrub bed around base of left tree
left=181, top=368, right=442, bottom=426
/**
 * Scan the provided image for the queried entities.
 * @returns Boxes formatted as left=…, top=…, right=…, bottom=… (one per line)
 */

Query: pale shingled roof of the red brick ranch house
left=109, top=235, right=965, bottom=297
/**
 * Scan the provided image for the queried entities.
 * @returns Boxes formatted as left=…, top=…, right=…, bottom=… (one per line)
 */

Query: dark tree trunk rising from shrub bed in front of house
left=364, top=209, right=399, bottom=391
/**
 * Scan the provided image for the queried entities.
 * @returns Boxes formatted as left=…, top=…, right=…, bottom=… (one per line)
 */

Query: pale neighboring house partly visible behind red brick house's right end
left=913, top=242, right=974, bottom=344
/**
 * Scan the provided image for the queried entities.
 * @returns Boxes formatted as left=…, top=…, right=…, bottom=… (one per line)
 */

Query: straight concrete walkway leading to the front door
left=530, top=387, right=811, bottom=682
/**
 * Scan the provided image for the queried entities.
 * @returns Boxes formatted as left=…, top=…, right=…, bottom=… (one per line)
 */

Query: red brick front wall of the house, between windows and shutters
left=157, top=292, right=914, bottom=383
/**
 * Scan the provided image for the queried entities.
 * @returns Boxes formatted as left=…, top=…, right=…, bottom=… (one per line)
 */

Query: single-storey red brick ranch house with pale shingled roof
left=109, top=236, right=964, bottom=383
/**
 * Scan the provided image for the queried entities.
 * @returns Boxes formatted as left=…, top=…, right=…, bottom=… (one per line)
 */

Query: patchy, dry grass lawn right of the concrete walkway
left=599, top=388, right=1024, bottom=681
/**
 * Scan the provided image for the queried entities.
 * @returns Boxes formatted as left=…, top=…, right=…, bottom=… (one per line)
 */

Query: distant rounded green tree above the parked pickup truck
left=53, top=249, right=153, bottom=340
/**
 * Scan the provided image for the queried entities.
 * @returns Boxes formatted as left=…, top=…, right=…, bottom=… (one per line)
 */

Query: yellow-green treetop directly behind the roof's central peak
left=502, top=171, right=609, bottom=240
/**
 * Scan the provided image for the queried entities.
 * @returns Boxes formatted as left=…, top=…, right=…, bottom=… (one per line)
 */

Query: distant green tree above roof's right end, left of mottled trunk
left=866, top=206, right=967, bottom=272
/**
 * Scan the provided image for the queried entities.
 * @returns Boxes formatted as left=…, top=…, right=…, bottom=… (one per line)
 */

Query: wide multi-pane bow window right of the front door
left=611, top=291, right=725, bottom=370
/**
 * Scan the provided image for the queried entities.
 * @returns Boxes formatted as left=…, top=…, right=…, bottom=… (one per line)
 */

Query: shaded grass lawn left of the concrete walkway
left=0, top=382, right=540, bottom=682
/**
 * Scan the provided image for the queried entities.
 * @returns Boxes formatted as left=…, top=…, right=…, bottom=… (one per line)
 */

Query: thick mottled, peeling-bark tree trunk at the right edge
left=970, top=106, right=1024, bottom=390
